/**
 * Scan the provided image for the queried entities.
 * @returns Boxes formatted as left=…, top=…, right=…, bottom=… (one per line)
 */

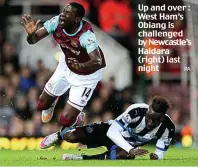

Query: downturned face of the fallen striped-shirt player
left=145, top=107, right=164, bottom=129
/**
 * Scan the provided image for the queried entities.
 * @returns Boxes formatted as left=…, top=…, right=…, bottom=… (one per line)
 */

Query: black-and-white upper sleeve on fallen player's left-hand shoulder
left=115, top=103, right=148, bottom=130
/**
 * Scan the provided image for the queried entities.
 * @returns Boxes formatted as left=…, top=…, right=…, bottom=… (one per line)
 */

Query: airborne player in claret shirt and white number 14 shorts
left=21, top=2, right=106, bottom=148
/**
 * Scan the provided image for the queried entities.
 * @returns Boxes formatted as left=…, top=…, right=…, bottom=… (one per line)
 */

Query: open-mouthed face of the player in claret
left=60, top=5, right=80, bottom=28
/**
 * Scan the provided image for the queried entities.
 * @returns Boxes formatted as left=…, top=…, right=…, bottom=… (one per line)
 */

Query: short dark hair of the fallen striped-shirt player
left=151, top=96, right=171, bottom=114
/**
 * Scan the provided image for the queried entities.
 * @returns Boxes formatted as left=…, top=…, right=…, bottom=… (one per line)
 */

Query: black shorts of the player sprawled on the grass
left=76, top=122, right=115, bottom=150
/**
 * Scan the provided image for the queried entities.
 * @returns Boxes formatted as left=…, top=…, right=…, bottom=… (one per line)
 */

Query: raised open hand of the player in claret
left=21, top=14, right=41, bottom=35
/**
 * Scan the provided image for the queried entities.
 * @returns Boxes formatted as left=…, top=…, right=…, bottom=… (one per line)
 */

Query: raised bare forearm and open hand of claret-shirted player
left=21, top=15, right=49, bottom=44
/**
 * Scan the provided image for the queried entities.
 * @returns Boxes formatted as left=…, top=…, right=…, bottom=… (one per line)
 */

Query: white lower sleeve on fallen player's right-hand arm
left=155, top=127, right=175, bottom=159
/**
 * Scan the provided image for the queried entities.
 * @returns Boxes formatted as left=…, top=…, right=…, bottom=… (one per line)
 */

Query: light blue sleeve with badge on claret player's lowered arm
left=80, top=30, right=98, bottom=54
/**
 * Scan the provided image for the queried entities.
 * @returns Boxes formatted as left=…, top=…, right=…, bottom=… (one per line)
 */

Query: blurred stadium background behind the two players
left=0, top=0, right=198, bottom=149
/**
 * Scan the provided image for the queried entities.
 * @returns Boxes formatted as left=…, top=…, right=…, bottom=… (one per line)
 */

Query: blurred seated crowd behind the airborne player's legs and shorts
left=0, top=42, right=133, bottom=136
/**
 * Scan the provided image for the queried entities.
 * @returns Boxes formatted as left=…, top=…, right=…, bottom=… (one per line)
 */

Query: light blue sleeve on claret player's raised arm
left=43, top=16, right=59, bottom=34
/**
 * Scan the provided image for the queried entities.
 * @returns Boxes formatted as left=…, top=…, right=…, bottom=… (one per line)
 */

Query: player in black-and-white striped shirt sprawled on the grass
left=43, top=96, right=175, bottom=160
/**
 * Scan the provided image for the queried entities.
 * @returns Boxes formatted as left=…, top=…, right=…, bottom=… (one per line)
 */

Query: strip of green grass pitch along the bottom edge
left=0, top=147, right=198, bottom=166
